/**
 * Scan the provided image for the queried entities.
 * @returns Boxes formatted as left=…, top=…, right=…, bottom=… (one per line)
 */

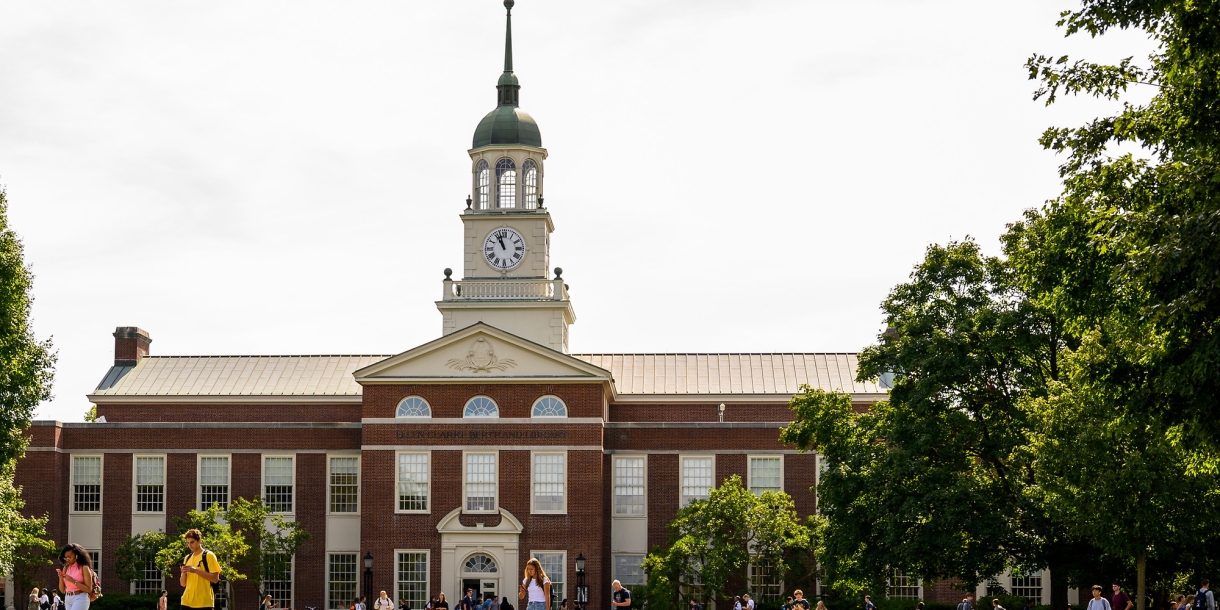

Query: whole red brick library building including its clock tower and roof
left=9, top=0, right=1058, bottom=610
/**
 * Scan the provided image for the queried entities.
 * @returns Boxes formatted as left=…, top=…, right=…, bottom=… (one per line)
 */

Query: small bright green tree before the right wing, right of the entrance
left=643, top=475, right=814, bottom=610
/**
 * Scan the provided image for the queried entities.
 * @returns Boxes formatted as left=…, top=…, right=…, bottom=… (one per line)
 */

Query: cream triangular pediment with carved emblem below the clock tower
left=354, top=322, right=611, bottom=384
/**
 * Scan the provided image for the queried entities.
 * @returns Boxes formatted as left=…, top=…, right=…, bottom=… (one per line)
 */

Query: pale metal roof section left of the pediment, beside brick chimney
left=92, top=355, right=389, bottom=397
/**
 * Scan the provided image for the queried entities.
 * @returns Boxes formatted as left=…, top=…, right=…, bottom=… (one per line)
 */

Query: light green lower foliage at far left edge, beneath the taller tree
left=0, top=462, right=59, bottom=592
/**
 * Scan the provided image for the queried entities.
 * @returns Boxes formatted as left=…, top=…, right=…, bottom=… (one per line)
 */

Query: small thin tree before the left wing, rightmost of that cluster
left=224, top=497, right=310, bottom=594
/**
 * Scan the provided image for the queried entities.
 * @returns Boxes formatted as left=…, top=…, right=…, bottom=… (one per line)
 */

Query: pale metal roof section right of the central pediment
left=572, top=354, right=886, bottom=395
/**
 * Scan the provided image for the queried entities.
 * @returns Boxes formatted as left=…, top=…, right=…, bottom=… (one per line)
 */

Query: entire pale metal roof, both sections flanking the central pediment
left=90, top=354, right=886, bottom=397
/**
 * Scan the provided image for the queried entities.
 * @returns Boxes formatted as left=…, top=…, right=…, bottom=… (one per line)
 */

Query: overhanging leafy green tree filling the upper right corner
left=1027, top=0, right=1220, bottom=445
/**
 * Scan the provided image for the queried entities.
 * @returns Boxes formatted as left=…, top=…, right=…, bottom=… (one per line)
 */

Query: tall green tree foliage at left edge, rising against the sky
left=0, top=188, right=56, bottom=463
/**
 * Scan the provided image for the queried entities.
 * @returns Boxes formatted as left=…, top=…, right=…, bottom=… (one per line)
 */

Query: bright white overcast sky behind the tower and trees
left=0, top=0, right=1153, bottom=421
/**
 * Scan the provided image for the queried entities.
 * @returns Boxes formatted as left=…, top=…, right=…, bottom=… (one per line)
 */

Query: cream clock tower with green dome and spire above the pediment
left=437, top=0, right=576, bottom=353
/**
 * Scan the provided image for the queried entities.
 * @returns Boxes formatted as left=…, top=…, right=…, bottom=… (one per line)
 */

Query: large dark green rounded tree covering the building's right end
left=780, top=239, right=1107, bottom=606
